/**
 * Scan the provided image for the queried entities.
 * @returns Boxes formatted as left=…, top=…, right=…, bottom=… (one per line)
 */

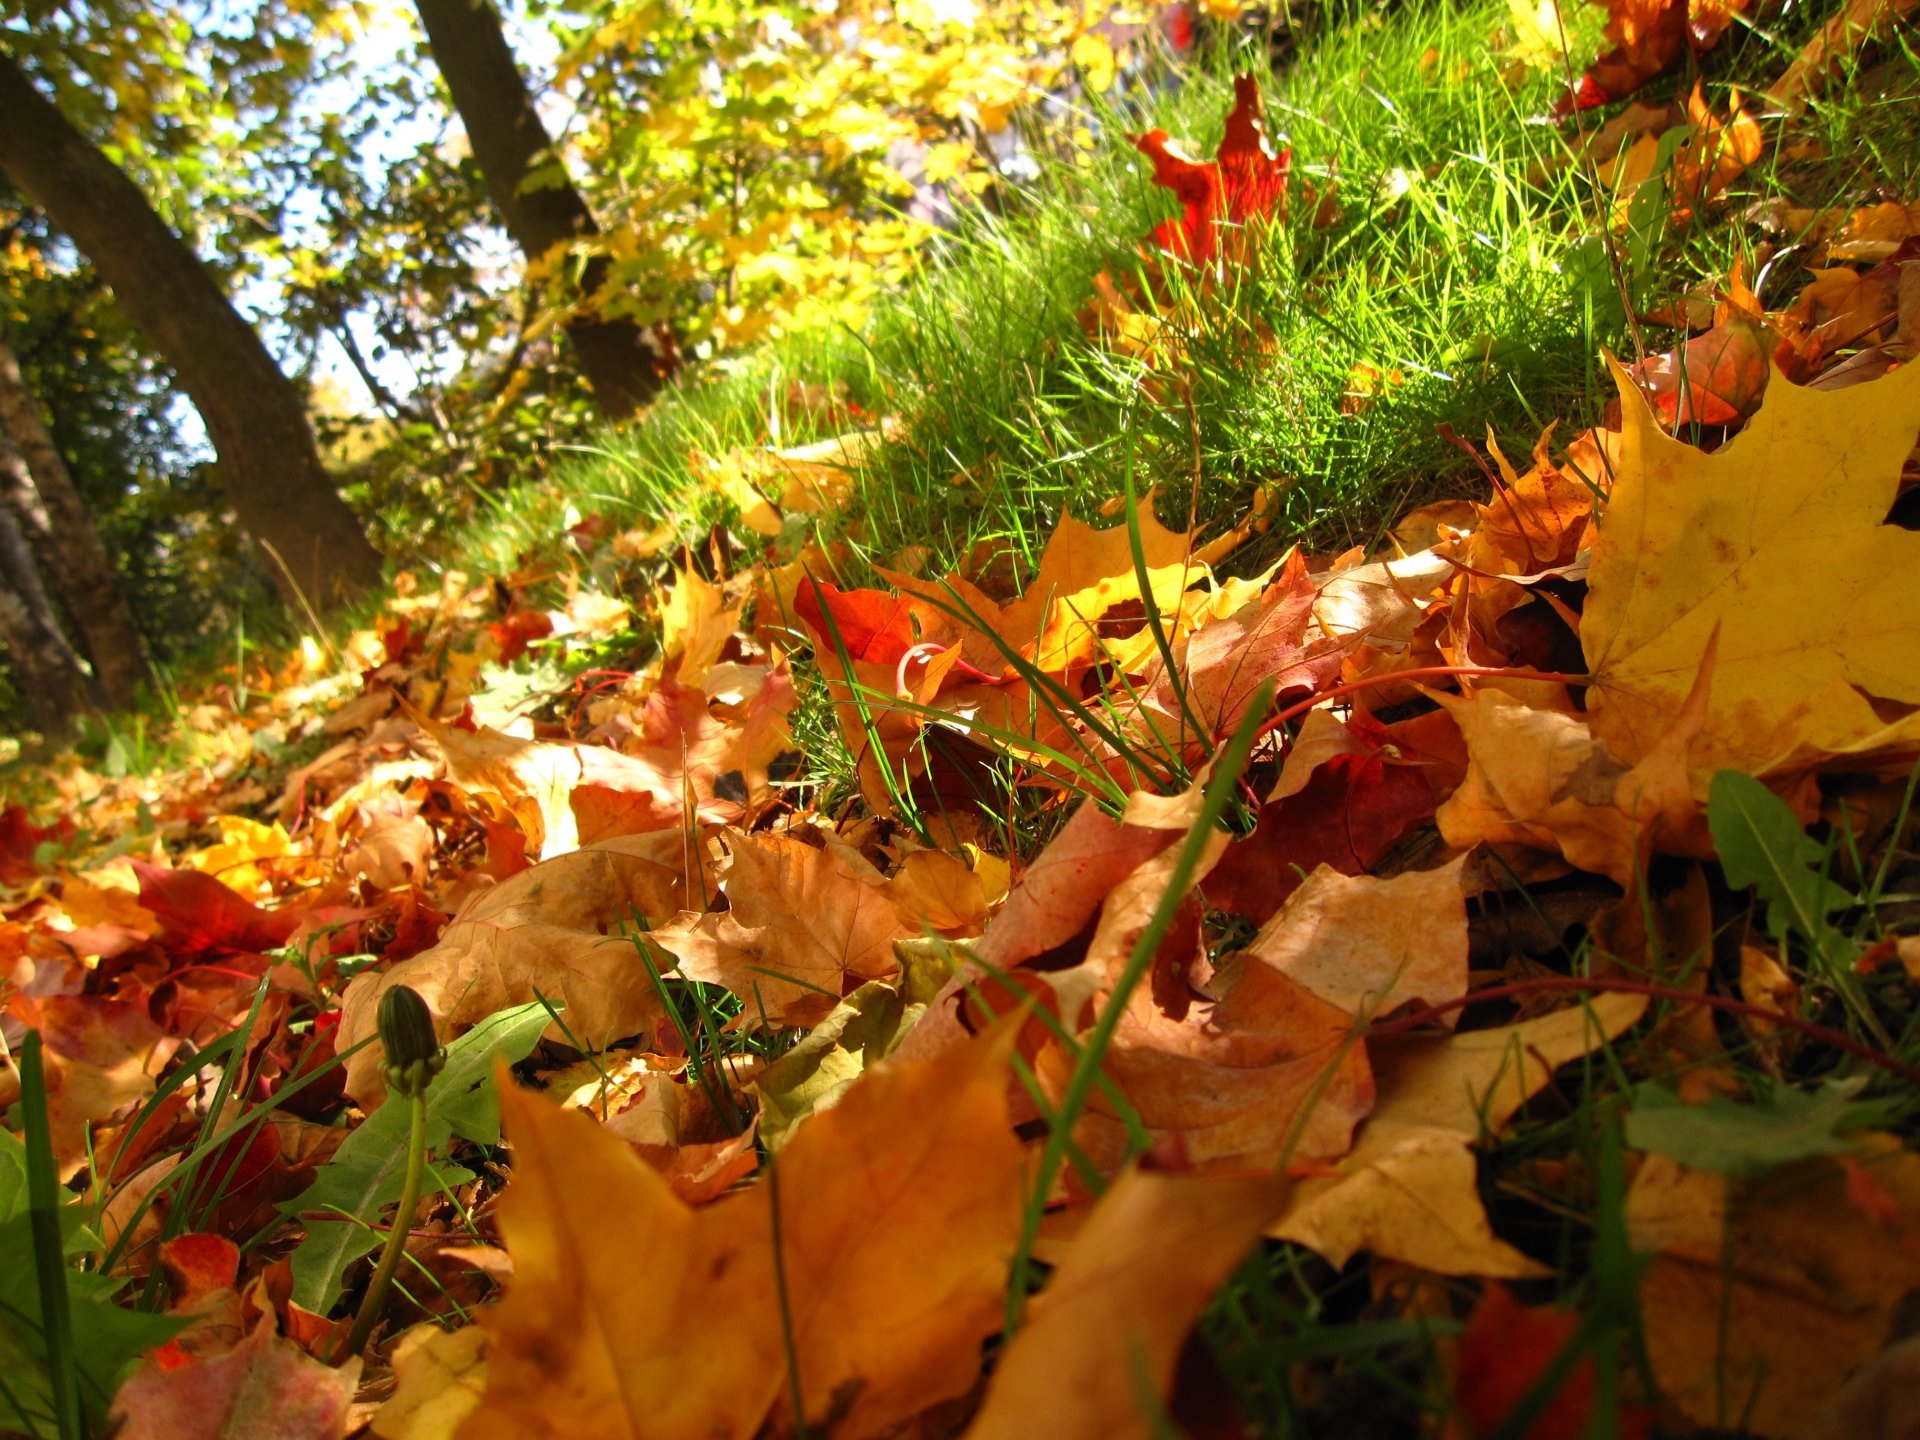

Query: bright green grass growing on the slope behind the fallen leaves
left=435, top=14, right=1920, bottom=1436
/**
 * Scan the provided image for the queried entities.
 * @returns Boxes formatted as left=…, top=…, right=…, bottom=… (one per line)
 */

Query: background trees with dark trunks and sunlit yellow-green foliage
left=0, top=0, right=1112, bottom=733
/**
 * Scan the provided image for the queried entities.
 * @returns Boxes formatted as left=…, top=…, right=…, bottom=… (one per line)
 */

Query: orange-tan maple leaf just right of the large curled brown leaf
left=655, top=829, right=920, bottom=1025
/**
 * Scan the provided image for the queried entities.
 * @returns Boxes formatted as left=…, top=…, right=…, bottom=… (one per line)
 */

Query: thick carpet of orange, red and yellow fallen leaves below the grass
left=0, top=33, right=1920, bottom=1440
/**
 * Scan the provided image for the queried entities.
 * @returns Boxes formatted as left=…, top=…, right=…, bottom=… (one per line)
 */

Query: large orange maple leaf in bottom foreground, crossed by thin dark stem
left=459, top=1031, right=1023, bottom=1440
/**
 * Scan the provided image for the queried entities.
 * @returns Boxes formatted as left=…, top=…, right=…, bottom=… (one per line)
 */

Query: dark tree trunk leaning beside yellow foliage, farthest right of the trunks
left=415, top=0, right=664, bottom=420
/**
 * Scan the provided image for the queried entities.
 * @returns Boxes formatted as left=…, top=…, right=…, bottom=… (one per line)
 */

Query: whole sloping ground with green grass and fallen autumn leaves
left=0, top=2, right=1920, bottom=1440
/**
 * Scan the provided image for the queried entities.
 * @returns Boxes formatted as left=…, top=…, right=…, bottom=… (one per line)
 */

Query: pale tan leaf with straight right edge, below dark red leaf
left=1246, top=856, right=1467, bottom=1020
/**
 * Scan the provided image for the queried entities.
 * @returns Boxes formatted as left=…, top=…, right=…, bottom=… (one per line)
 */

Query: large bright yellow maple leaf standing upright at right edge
left=1580, top=365, right=1920, bottom=774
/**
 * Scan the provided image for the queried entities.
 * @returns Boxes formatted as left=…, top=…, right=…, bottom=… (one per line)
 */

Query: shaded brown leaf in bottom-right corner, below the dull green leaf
left=1626, top=1135, right=1920, bottom=1436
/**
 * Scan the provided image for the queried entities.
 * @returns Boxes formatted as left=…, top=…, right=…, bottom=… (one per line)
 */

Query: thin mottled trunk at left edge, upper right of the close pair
left=0, top=340, right=152, bottom=708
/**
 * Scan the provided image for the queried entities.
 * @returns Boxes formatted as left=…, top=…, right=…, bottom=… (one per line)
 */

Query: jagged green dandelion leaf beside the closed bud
left=282, top=1002, right=553, bottom=1315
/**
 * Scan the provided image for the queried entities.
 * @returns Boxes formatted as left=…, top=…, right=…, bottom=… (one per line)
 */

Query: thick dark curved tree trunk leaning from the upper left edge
left=0, top=52, right=380, bottom=605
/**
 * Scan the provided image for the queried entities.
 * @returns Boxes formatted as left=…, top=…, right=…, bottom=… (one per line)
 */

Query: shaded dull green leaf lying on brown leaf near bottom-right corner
left=1626, top=1079, right=1889, bottom=1177
